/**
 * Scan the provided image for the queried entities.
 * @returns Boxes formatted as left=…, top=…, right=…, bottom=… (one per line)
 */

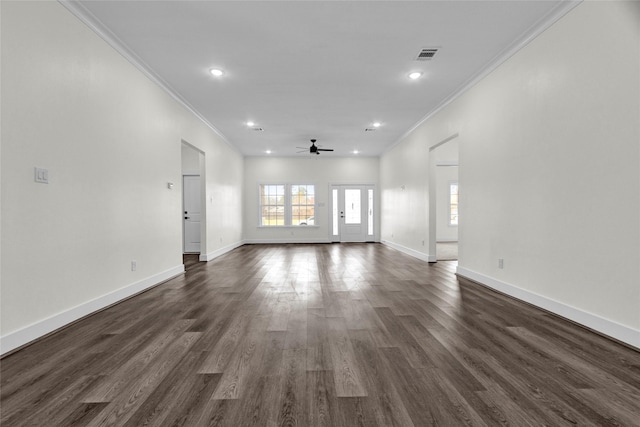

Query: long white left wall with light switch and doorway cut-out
left=0, top=1, right=243, bottom=352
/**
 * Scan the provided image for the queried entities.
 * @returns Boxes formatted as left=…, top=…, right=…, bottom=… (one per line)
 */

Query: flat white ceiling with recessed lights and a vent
left=66, top=0, right=567, bottom=156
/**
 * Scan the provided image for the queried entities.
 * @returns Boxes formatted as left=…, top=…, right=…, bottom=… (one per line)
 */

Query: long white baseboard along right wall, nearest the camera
left=456, top=266, right=640, bottom=349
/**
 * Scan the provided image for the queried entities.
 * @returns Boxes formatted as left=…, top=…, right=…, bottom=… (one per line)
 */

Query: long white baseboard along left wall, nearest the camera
left=0, top=264, right=184, bottom=355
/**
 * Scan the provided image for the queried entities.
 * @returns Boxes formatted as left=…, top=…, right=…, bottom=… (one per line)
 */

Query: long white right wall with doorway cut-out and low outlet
left=381, top=2, right=640, bottom=347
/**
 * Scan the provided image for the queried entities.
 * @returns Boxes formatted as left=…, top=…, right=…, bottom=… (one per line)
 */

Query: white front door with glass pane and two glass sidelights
left=330, top=185, right=375, bottom=242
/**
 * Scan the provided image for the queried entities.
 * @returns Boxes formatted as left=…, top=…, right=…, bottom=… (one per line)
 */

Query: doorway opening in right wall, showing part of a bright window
left=429, top=133, right=459, bottom=262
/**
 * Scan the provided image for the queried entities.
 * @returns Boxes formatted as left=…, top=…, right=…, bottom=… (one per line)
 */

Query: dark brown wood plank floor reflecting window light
left=0, top=244, right=640, bottom=427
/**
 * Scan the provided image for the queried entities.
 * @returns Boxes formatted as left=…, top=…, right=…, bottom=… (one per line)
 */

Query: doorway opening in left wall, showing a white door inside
left=181, top=141, right=206, bottom=259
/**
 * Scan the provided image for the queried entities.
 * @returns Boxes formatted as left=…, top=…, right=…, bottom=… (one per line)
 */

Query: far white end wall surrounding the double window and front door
left=244, top=154, right=379, bottom=243
